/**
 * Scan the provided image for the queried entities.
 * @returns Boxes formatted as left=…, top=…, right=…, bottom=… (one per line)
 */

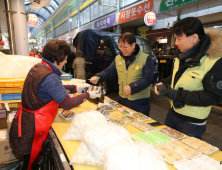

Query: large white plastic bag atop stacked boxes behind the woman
left=0, top=53, right=42, bottom=78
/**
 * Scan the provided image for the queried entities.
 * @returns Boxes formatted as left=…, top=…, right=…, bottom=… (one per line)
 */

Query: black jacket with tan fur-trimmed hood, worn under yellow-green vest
left=161, top=29, right=222, bottom=123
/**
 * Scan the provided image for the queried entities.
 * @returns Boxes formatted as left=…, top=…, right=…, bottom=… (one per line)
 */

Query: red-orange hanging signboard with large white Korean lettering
left=119, top=0, right=153, bottom=24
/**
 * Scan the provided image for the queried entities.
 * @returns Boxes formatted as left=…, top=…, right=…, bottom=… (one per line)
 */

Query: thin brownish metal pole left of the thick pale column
left=5, top=0, right=16, bottom=55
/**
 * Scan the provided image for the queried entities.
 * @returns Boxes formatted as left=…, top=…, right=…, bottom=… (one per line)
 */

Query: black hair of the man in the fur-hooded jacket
left=172, top=17, right=205, bottom=39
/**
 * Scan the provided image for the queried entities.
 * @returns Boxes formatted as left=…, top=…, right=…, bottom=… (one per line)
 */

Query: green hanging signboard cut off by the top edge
left=159, top=0, right=202, bottom=12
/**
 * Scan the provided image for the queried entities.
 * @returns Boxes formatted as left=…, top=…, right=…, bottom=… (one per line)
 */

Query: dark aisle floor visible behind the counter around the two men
left=107, top=87, right=222, bottom=150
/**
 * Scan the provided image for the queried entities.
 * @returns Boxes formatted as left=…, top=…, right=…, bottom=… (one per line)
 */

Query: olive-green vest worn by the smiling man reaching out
left=115, top=52, right=150, bottom=100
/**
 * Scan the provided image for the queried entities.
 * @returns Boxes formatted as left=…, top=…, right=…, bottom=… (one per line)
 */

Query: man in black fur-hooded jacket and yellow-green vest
left=155, top=17, right=222, bottom=139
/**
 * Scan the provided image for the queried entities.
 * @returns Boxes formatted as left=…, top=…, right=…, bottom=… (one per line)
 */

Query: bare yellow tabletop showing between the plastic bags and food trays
left=52, top=101, right=222, bottom=170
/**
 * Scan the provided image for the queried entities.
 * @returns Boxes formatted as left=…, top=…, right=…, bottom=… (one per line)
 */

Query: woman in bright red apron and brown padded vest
left=10, top=40, right=100, bottom=170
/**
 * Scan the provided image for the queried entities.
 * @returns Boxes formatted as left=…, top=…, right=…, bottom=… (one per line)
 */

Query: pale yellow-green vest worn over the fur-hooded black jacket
left=170, top=55, right=220, bottom=119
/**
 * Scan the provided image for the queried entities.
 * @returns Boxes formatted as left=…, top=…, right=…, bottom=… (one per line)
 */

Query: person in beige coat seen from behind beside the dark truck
left=72, top=50, right=86, bottom=80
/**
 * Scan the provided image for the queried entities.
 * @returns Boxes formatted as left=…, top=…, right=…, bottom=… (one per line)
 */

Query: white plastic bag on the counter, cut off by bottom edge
left=103, top=141, right=168, bottom=170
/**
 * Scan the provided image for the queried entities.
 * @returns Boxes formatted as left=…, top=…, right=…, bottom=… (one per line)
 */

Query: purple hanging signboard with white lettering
left=94, top=14, right=115, bottom=30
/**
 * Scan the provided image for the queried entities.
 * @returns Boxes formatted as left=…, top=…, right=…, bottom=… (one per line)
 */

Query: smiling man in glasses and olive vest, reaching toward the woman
left=90, top=32, right=154, bottom=116
